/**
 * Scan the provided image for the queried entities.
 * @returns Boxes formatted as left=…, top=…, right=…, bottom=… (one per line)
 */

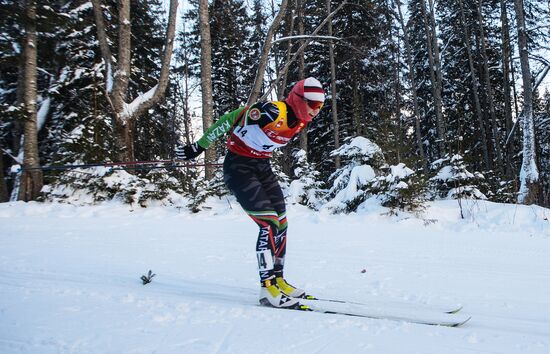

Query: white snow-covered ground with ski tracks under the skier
left=0, top=200, right=550, bottom=354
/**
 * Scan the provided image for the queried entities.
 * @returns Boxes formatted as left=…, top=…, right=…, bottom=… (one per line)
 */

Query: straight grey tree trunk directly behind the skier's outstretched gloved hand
left=199, top=0, right=216, bottom=179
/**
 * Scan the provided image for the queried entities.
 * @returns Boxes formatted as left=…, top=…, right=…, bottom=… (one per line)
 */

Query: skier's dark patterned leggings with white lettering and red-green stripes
left=223, top=152, right=287, bottom=281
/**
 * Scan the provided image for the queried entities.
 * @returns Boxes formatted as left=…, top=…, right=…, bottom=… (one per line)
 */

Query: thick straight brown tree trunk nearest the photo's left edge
left=18, top=0, right=43, bottom=201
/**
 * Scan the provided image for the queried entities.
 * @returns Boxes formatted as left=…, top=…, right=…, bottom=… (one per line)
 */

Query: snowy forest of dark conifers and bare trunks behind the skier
left=0, top=0, right=550, bottom=212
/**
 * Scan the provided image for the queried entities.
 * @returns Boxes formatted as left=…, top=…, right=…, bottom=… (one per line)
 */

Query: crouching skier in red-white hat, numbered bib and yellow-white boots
left=176, top=77, right=325, bottom=308
